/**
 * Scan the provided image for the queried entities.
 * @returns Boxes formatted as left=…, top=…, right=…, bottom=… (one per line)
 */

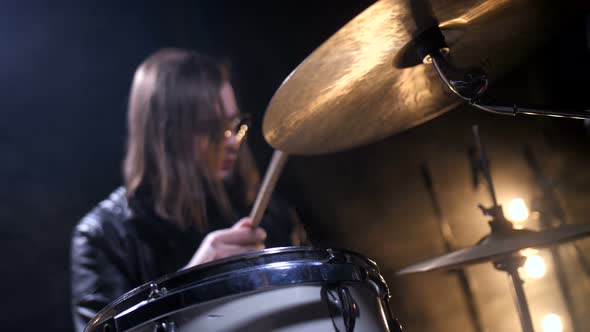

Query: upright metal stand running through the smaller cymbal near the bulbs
left=473, top=126, right=534, bottom=332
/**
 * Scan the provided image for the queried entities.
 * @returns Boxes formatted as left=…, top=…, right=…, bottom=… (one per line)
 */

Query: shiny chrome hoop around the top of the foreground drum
left=86, top=247, right=390, bottom=332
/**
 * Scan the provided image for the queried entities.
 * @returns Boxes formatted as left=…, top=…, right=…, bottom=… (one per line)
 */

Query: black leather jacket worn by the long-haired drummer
left=71, top=188, right=298, bottom=331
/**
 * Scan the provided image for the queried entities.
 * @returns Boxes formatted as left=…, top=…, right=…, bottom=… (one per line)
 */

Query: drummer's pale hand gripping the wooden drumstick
left=184, top=218, right=266, bottom=269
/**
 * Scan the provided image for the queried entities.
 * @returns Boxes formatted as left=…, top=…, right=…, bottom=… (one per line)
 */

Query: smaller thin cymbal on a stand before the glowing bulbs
left=397, top=225, right=590, bottom=274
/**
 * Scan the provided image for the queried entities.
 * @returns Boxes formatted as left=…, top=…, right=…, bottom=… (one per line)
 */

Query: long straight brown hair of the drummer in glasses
left=123, top=49, right=259, bottom=229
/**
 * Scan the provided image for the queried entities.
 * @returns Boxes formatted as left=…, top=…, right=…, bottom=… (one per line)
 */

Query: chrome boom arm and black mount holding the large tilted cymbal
left=413, top=26, right=590, bottom=119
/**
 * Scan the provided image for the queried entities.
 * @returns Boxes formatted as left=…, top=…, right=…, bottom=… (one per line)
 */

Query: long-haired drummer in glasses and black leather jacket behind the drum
left=71, top=49, right=303, bottom=330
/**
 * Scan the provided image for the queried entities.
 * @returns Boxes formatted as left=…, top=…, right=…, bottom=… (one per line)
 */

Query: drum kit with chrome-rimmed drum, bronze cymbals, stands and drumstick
left=86, top=0, right=590, bottom=332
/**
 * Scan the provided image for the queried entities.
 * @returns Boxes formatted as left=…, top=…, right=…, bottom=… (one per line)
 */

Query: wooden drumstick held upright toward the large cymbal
left=250, top=150, right=289, bottom=228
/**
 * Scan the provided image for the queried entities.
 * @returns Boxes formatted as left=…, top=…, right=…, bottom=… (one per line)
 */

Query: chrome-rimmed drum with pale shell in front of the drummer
left=85, top=247, right=401, bottom=332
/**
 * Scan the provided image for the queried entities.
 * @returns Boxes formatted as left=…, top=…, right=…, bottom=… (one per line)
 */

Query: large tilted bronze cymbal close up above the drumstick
left=263, top=0, right=588, bottom=155
